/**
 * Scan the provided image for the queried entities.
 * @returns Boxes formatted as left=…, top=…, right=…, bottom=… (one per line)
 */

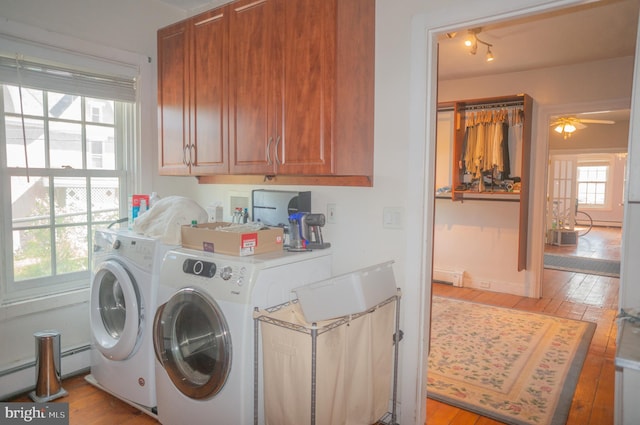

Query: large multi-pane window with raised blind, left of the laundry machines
left=0, top=57, right=135, bottom=299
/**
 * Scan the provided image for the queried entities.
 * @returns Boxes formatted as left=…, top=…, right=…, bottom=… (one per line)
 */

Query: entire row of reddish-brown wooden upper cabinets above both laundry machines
left=158, top=0, right=375, bottom=186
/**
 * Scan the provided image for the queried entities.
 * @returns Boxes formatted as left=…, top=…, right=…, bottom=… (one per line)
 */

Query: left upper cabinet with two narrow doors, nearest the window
left=158, top=7, right=229, bottom=175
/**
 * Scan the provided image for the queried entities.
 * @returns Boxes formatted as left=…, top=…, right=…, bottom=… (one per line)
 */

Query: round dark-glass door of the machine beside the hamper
left=153, top=288, right=231, bottom=399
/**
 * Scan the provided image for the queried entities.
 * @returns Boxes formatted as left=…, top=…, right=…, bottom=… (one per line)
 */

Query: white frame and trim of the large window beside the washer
left=0, top=36, right=142, bottom=306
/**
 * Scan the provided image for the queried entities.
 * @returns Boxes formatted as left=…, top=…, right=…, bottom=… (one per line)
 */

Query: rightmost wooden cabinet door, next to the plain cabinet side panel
left=276, top=0, right=336, bottom=175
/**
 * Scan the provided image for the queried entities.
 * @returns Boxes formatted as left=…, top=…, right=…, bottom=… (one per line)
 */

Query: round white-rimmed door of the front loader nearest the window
left=90, top=260, right=142, bottom=360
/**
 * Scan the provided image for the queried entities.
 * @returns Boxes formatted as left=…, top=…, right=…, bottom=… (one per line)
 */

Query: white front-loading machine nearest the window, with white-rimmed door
left=87, top=229, right=176, bottom=413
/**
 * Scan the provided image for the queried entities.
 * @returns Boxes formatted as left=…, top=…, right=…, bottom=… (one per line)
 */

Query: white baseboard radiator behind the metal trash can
left=0, top=345, right=91, bottom=400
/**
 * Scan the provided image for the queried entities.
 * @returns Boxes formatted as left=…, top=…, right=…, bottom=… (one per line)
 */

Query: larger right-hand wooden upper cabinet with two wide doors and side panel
left=229, top=0, right=375, bottom=179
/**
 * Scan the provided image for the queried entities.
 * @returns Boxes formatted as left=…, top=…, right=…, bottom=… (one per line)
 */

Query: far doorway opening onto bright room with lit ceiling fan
left=544, top=109, right=630, bottom=261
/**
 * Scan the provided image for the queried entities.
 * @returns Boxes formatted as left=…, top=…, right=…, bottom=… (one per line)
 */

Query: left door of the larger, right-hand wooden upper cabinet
left=229, top=0, right=279, bottom=174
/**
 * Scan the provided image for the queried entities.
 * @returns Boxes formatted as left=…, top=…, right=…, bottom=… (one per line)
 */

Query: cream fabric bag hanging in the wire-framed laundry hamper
left=261, top=302, right=395, bottom=425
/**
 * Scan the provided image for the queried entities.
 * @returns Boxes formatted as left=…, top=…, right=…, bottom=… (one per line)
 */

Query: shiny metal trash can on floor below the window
left=29, top=331, right=68, bottom=403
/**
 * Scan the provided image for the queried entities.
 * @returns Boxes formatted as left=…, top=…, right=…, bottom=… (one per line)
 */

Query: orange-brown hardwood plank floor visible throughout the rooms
left=7, top=229, right=620, bottom=425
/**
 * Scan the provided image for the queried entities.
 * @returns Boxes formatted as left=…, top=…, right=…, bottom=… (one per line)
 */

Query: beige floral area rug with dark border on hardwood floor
left=427, top=297, right=596, bottom=425
